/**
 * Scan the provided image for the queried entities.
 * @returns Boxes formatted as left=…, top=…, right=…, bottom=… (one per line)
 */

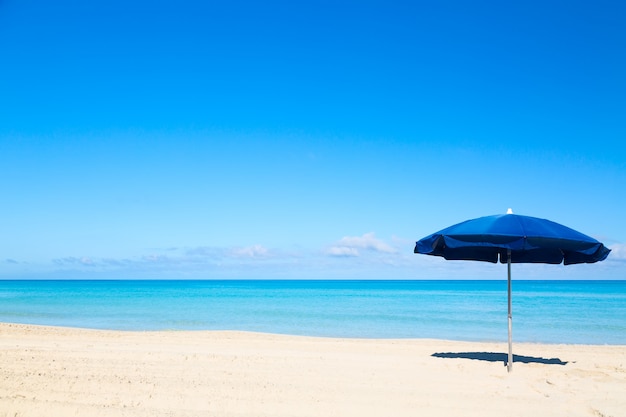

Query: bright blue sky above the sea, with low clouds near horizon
left=0, top=0, right=626, bottom=279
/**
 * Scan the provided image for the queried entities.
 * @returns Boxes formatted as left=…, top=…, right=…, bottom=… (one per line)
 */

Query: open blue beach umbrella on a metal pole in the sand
left=414, top=209, right=611, bottom=372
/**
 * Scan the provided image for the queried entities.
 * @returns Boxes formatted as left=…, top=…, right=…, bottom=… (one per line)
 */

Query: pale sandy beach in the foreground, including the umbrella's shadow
left=0, top=323, right=626, bottom=417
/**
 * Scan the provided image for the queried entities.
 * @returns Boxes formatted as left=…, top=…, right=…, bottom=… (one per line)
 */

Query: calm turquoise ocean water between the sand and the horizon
left=0, top=280, right=626, bottom=345
